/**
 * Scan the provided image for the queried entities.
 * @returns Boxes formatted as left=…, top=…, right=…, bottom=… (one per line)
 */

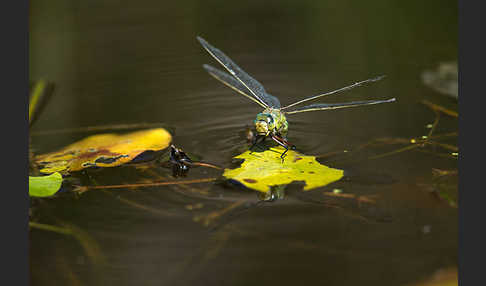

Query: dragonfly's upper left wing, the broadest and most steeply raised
left=197, top=37, right=280, bottom=108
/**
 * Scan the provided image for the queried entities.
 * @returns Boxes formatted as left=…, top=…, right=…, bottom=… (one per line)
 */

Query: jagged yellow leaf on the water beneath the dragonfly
left=223, top=146, right=343, bottom=192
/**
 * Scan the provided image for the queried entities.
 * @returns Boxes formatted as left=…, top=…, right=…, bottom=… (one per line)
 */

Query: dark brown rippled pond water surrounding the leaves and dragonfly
left=30, top=1, right=457, bottom=285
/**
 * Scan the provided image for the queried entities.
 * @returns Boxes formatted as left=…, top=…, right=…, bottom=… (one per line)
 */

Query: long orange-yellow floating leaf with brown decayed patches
left=36, top=128, right=172, bottom=173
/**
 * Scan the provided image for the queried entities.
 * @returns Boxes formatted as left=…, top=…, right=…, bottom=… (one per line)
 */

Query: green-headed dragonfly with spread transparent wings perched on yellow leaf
left=197, top=36, right=396, bottom=160
